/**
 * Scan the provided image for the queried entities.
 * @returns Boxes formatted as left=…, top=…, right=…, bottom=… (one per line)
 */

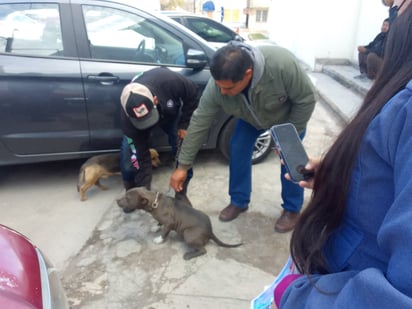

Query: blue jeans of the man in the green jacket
left=229, top=119, right=305, bottom=212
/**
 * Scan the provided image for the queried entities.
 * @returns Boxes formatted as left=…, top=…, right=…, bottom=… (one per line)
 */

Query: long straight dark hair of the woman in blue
left=290, top=6, right=412, bottom=274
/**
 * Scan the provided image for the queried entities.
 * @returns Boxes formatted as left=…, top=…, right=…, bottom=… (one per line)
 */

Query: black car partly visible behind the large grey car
left=161, top=11, right=245, bottom=47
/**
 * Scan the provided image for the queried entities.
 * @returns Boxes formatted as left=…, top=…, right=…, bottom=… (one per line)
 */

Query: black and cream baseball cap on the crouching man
left=120, top=83, right=159, bottom=130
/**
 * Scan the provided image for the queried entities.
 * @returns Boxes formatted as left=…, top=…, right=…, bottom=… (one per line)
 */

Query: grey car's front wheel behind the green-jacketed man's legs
left=219, top=118, right=273, bottom=164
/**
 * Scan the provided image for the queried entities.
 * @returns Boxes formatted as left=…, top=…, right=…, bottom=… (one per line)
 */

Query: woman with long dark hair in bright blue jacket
left=275, top=1, right=412, bottom=309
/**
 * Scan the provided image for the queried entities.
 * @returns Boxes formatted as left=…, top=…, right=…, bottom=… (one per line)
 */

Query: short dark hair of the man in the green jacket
left=210, top=43, right=253, bottom=83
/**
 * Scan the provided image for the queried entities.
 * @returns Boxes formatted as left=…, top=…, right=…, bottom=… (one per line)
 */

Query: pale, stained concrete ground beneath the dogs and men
left=0, top=63, right=361, bottom=309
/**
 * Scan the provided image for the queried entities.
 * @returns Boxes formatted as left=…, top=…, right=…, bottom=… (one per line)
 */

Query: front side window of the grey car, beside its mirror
left=82, top=5, right=185, bottom=65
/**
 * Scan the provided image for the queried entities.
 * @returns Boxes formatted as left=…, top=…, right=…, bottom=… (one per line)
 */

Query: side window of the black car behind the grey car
left=182, top=18, right=233, bottom=43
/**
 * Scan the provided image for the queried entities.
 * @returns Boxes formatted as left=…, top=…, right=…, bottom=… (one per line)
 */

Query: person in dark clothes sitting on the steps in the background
left=355, top=18, right=389, bottom=79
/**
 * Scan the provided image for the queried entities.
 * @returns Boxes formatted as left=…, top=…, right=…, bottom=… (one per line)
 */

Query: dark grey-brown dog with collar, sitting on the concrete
left=117, top=187, right=241, bottom=260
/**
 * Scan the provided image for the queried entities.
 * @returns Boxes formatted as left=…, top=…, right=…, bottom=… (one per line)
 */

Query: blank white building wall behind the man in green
left=268, top=0, right=388, bottom=69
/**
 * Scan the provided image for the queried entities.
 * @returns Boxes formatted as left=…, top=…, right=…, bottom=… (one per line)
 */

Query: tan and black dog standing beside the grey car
left=77, top=148, right=161, bottom=201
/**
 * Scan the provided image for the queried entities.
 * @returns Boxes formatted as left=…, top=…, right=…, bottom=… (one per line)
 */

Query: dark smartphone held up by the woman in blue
left=270, top=123, right=314, bottom=183
